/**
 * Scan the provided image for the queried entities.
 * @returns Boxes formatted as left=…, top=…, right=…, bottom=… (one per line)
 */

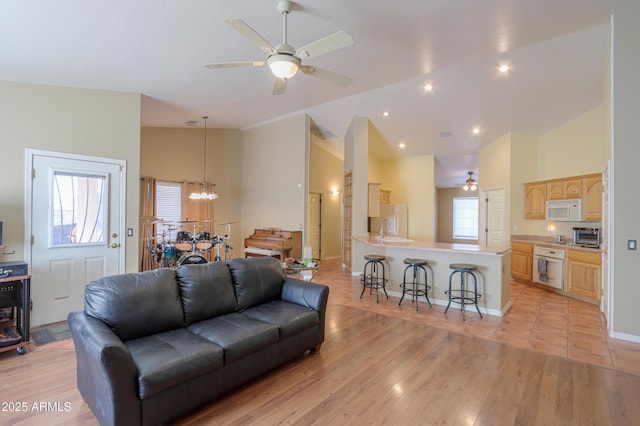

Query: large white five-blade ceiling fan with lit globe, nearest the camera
left=206, top=1, right=353, bottom=95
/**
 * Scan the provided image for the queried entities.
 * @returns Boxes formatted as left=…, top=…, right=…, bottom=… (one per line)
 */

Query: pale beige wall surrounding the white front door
left=0, top=82, right=140, bottom=271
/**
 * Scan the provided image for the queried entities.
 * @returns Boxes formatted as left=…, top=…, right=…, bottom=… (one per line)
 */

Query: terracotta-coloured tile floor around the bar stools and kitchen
left=314, top=260, right=640, bottom=375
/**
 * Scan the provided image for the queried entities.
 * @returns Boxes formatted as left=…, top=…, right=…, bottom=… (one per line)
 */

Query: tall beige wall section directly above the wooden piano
left=240, top=114, right=310, bottom=246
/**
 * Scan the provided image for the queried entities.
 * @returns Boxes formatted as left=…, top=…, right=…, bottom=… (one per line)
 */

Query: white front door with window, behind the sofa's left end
left=27, top=150, right=124, bottom=326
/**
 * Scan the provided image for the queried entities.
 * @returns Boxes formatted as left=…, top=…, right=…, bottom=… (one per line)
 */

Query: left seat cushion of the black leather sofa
left=125, top=328, right=224, bottom=399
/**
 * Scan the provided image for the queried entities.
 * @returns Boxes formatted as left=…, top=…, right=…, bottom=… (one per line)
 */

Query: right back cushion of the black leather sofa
left=227, top=257, right=284, bottom=312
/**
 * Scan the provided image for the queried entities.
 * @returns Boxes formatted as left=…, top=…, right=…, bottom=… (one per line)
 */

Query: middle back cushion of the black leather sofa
left=176, top=262, right=238, bottom=325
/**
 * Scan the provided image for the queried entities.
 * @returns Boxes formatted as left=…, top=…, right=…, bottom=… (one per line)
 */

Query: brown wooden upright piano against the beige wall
left=244, top=228, right=302, bottom=261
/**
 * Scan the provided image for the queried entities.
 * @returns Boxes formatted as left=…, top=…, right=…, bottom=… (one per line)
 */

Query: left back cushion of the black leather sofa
left=84, top=268, right=184, bottom=341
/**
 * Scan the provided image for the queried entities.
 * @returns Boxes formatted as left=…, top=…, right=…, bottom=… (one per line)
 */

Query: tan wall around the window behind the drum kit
left=140, top=123, right=243, bottom=256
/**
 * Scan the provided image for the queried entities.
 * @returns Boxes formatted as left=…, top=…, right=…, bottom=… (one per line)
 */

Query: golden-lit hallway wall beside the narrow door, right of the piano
left=309, top=136, right=344, bottom=259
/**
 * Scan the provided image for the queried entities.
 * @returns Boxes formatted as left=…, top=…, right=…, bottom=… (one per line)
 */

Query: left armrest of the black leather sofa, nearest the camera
left=68, top=312, right=142, bottom=425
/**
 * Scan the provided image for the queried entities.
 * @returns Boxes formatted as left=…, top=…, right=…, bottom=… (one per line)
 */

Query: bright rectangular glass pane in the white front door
left=50, top=170, right=107, bottom=246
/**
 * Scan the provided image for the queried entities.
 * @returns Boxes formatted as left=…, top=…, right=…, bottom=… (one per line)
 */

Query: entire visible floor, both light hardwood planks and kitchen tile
left=0, top=261, right=640, bottom=425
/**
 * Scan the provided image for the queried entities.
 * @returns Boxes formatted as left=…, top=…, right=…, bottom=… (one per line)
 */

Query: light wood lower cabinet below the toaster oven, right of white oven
left=568, top=250, right=602, bottom=303
